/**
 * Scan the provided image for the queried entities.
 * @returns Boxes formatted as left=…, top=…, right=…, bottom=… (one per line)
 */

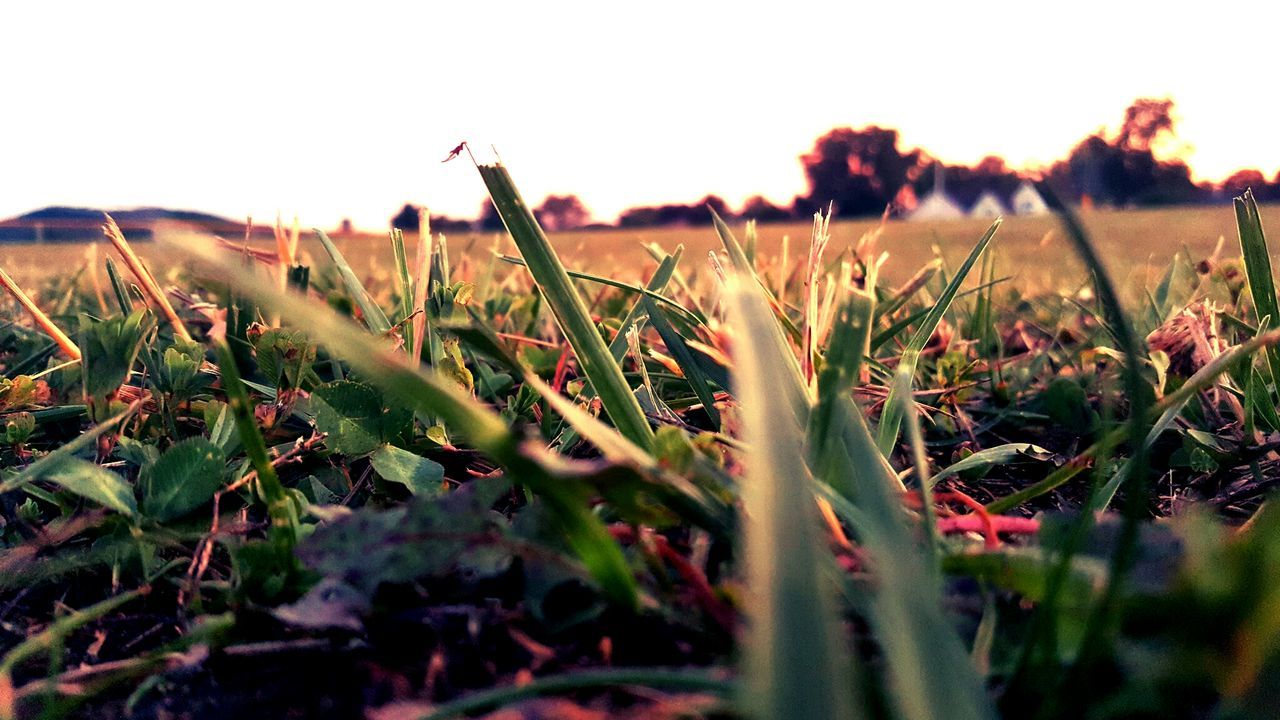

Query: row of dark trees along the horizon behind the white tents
left=392, top=99, right=1280, bottom=232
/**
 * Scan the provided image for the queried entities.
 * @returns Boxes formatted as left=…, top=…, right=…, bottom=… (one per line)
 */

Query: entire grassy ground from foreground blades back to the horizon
left=0, top=175, right=1280, bottom=720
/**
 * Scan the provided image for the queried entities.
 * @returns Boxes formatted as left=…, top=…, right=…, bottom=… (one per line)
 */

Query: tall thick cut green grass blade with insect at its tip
left=477, top=165, right=653, bottom=448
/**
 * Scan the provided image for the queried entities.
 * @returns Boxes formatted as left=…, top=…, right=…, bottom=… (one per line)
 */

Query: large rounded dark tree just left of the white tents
left=796, top=126, right=924, bottom=217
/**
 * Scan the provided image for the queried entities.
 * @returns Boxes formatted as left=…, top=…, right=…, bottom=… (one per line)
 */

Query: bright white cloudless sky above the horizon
left=0, top=0, right=1280, bottom=228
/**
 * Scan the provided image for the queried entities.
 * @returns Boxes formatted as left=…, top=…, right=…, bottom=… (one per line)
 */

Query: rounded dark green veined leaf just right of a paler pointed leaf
left=138, top=438, right=227, bottom=523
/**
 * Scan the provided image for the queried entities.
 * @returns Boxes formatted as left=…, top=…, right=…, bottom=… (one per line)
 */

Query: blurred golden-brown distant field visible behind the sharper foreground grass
left=0, top=205, right=1280, bottom=291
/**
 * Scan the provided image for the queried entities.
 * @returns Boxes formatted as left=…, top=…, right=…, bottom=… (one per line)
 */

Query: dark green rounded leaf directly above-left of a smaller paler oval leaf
left=311, top=380, right=410, bottom=456
